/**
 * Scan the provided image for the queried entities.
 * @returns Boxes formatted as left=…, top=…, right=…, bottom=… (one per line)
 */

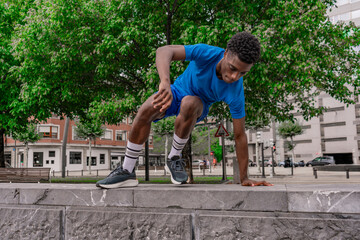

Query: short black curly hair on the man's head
left=227, top=32, right=260, bottom=64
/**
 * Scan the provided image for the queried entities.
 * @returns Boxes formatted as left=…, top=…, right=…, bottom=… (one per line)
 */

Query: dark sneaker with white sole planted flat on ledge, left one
left=96, top=166, right=139, bottom=188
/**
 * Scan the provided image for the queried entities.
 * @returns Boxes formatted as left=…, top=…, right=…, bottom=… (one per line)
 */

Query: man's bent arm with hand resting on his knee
left=153, top=45, right=186, bottom=112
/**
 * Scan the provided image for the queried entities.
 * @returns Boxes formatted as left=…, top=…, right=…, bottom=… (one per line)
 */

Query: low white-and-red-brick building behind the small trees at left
left=5, top=116, right=153, bottom=171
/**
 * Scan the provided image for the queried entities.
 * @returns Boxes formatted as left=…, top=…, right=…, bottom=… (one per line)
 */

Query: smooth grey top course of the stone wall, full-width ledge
left=0, top=183, right=360, bottom=213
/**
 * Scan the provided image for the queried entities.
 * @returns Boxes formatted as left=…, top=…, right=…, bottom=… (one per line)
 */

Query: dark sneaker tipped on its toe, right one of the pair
left=165, top=156, right=188, bottom=184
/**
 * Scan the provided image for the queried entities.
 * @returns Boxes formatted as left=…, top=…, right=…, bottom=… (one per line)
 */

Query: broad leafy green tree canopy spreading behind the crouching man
left=14, top=0, right=360, bottom=125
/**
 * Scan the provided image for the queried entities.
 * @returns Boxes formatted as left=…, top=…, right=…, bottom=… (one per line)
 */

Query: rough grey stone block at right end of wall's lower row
left=195, top=212, right=360, bottom=240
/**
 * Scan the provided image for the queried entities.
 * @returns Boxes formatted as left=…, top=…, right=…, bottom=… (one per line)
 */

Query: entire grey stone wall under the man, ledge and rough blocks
left=0, top=183, right=360, bottom=239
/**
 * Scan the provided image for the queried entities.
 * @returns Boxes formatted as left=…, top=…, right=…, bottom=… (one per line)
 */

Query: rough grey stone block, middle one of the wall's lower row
left=66, top=207, right=192, bottom=240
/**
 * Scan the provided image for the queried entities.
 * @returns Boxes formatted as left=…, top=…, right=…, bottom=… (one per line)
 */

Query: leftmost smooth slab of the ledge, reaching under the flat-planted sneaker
left=0, top=183, right=133, bottom=207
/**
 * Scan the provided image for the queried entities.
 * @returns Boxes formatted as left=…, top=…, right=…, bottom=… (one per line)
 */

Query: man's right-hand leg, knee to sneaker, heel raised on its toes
left=166, top=96, right=203, bottom=184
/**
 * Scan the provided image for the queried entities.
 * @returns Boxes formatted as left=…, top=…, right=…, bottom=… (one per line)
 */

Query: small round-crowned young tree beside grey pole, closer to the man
left=75, top=119, right=105, bottom=174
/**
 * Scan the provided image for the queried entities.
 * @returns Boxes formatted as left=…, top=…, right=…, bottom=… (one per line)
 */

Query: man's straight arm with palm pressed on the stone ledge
left=233, top=117, right=273, bottom=186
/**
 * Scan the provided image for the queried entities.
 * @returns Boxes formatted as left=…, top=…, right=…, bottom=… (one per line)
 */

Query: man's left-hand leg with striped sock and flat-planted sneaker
left=96, top=96, right=164, bottom=188
